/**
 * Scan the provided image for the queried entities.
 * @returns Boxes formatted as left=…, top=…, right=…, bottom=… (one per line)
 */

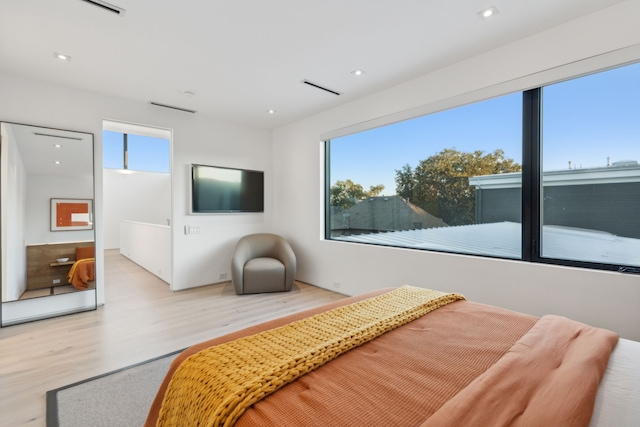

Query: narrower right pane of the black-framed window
left=540, top=64, right=640, bottom=266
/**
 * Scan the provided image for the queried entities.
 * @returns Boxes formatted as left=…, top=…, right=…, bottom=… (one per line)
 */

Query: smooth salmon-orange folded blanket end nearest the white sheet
left=421, top=316, right=618, bottom=427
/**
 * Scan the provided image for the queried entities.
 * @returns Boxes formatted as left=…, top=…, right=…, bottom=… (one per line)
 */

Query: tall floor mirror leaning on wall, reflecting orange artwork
left=0, top=122, right=97, bottom=326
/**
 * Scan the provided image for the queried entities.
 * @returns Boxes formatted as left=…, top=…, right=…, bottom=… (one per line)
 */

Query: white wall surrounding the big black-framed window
left=273, top=1, right=640, bottom=340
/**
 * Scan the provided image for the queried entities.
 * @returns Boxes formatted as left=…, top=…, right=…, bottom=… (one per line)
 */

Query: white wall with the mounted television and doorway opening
left=0, top=74, right=273, bottom=304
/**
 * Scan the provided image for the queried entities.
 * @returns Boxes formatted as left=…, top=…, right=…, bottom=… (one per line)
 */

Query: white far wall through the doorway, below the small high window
left=103, top=169, right=171, bottom=251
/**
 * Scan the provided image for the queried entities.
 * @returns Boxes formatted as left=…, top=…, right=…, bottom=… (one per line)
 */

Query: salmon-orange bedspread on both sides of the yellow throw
left=145, top=290, right=617, bottom=427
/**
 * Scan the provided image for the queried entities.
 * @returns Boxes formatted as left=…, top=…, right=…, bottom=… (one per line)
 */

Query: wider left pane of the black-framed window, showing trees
left=327, top=93, right=522, bottom=258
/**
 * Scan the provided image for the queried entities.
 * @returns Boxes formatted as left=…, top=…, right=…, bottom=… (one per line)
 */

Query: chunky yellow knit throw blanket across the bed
left=157, top=286, right=464, bottom=427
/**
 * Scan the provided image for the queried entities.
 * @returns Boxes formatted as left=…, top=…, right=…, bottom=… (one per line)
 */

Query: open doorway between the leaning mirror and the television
left=102, top=120, right=172, bottom=289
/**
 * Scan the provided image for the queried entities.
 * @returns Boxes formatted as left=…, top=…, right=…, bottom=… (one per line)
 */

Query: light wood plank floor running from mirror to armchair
left=0, top=250, right=344, bottom=427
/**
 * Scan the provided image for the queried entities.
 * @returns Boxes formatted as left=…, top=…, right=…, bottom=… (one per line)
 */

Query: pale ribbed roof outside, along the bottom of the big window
left=334, top=222, right=640, bottom=266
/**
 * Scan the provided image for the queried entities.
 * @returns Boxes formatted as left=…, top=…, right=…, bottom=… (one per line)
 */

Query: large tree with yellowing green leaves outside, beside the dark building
left=396, top=148, right=521, bottom=225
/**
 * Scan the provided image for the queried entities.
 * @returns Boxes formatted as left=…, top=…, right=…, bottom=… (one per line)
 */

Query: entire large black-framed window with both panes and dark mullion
left=325, top=64, right=640, bottom=269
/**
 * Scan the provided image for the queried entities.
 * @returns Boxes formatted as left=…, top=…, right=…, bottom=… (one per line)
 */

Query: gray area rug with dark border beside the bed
left=47, top=351, right=180, bottom=427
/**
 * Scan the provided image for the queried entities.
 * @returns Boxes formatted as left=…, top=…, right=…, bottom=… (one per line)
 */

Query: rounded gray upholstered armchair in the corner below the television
left=231, top=233, right=296, bottom=295
